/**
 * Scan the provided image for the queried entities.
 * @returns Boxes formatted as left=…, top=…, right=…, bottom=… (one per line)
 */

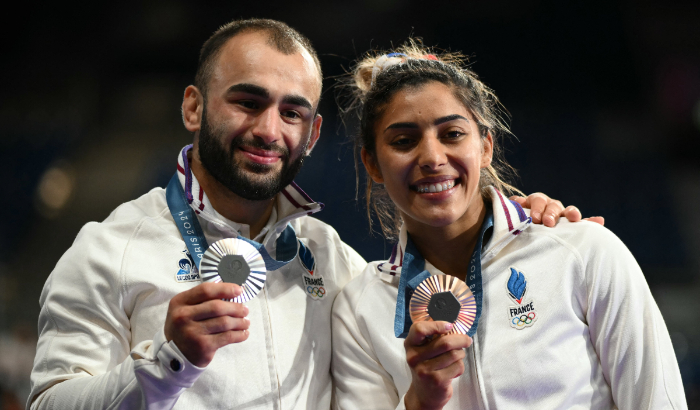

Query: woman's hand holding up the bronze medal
left=404, top=321, right=472, bottom=410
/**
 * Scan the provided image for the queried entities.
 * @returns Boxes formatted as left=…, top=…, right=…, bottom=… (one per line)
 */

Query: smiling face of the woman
left=363, top=82, right=492, bottom=228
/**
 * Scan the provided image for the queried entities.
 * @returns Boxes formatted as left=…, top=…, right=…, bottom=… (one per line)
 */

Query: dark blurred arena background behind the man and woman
left=0, top=0, right=700, bottom=409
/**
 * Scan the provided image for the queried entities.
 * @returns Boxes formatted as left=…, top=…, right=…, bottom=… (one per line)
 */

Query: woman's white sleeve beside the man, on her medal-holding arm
left=331, top=270, right=404, bottom=410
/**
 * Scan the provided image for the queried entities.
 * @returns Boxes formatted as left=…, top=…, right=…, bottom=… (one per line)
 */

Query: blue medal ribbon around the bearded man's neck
left=165, top=173, right=306, bottom=271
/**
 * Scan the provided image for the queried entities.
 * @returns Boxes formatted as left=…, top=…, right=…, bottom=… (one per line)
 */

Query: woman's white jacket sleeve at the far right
left=583, top=227, right=688, bottom=410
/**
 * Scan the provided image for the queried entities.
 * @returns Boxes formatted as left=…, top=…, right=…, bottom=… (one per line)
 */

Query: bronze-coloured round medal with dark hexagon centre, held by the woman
left=409, top=275, right=476, bottom=335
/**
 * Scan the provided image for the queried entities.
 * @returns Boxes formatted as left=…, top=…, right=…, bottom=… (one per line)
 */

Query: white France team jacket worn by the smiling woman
left=332, top=189, right=687, bottom=410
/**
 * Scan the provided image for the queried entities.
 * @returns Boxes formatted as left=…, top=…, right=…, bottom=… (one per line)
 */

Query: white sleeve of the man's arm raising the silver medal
left=27, top=223, right=203, bottom=410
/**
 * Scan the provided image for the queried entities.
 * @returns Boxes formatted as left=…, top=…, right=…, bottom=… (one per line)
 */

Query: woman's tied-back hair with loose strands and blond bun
left=338, top=38, right=520, bottom=240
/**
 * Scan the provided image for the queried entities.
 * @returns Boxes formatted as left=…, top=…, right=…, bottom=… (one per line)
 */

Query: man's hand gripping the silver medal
left=165, top=282, right=250, bottom=367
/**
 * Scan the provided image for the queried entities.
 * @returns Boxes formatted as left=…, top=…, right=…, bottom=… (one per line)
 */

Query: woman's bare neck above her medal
left=404, top=200, right=486, bottom=280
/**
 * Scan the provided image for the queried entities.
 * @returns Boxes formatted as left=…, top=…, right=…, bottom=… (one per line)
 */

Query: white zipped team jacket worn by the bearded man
left=28, top=146, right=366, bottom=410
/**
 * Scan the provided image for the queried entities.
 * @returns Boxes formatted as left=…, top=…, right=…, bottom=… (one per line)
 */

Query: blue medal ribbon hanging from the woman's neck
left=394, top=207, right=493, bottom=338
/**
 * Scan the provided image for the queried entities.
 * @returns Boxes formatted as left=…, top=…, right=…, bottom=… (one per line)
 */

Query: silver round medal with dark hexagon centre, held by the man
left=200, top=238, right=267, bottom=303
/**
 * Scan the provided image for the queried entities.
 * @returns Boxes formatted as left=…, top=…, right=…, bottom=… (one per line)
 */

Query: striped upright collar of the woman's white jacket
left=377, top=187, right=532, bottom=284
